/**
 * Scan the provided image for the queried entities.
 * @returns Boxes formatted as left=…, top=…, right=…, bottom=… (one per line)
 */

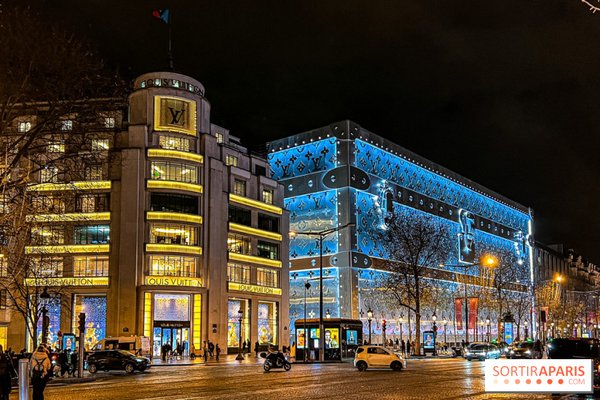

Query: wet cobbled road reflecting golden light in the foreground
left=11, top=359, right=596, bottom=400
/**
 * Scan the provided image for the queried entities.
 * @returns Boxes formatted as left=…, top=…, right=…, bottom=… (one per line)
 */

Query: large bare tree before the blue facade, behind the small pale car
left=378, top=212, right=451, bottom=354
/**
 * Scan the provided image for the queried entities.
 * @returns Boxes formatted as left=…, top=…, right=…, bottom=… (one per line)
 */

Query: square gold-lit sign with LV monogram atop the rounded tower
left=154, top=96, right=196, bottom=136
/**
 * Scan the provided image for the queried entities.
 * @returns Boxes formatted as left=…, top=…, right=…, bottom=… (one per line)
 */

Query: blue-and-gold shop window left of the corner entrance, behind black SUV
left=72, top=295, right=106, bottom=350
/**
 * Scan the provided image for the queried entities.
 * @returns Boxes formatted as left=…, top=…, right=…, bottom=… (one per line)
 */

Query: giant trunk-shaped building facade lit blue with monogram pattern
left=268, top=121, right=533, bottom=342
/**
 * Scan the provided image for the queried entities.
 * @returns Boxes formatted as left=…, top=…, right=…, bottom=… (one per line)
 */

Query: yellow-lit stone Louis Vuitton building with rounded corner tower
left=0, top=72, right=289, bottom=356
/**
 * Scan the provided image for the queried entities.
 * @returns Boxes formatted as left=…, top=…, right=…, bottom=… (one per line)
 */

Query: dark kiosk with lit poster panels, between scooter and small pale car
left=295, top=318, right=363, bottom=362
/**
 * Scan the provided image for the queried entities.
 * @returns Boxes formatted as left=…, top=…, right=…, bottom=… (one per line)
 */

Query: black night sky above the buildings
left=27, top=0, right=600, bottom=264
